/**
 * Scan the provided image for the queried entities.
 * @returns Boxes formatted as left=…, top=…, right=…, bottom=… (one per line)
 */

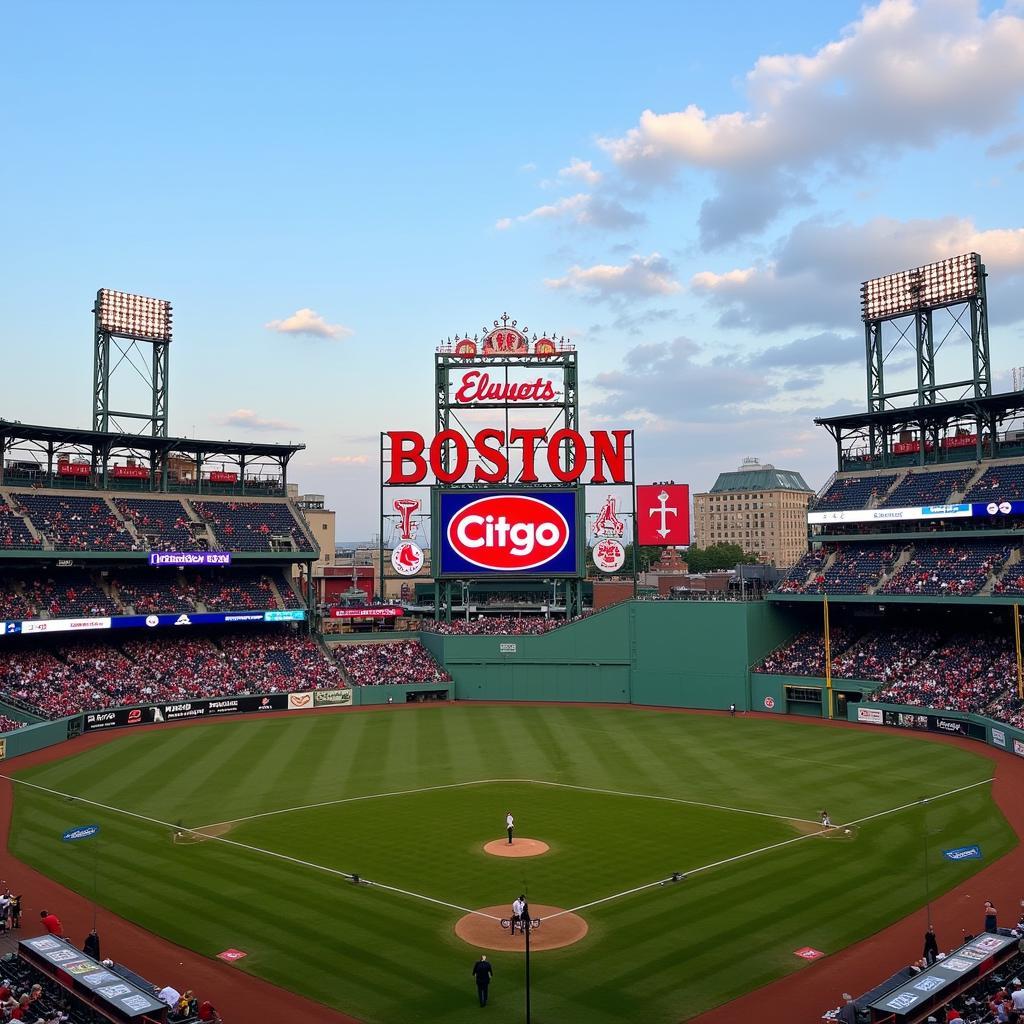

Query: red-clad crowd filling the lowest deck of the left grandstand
left=0, top=627, right=340, bottom=718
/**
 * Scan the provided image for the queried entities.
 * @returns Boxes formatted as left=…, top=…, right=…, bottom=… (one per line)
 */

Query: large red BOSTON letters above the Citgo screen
left=386, top=427, right=632, bottom=484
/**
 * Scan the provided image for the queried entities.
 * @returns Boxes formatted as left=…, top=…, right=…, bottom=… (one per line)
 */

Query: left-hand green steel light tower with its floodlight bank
left=92, top=288, right=172, bottom=437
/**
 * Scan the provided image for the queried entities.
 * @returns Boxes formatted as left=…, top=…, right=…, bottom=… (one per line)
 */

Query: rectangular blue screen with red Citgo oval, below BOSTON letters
left=437, top=490, right=579, bottom=575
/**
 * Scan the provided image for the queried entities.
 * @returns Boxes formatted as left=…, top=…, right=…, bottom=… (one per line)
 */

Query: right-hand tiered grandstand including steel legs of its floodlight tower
left=765, top=257, right=1024, bottom=731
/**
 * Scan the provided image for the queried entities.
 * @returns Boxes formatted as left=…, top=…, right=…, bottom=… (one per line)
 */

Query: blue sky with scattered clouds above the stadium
left=0, top=0, right=1024, bottom=538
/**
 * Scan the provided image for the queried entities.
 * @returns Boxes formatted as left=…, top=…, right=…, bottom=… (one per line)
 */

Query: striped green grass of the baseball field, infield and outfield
left=11, top=705, right=1016, bottom=1024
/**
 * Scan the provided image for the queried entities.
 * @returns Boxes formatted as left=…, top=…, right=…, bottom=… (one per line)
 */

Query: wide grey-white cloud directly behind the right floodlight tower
left=690, top=217, right=1024, bottom=331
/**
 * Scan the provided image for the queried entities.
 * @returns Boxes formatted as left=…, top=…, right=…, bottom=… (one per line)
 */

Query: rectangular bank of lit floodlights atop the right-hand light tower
left=860, top=253, right=984, bottom=321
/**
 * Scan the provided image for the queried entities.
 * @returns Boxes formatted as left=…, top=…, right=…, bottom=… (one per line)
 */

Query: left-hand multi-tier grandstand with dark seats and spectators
left=0, top=421, right=325, bottom=720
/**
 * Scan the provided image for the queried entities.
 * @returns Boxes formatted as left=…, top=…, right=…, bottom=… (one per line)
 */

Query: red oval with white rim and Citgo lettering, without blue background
left=447, top=495, right=569, bottom=571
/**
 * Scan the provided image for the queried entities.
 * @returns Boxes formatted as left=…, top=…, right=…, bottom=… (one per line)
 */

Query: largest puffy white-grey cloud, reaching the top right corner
left=600, top=0, right=1024, bottom=246
